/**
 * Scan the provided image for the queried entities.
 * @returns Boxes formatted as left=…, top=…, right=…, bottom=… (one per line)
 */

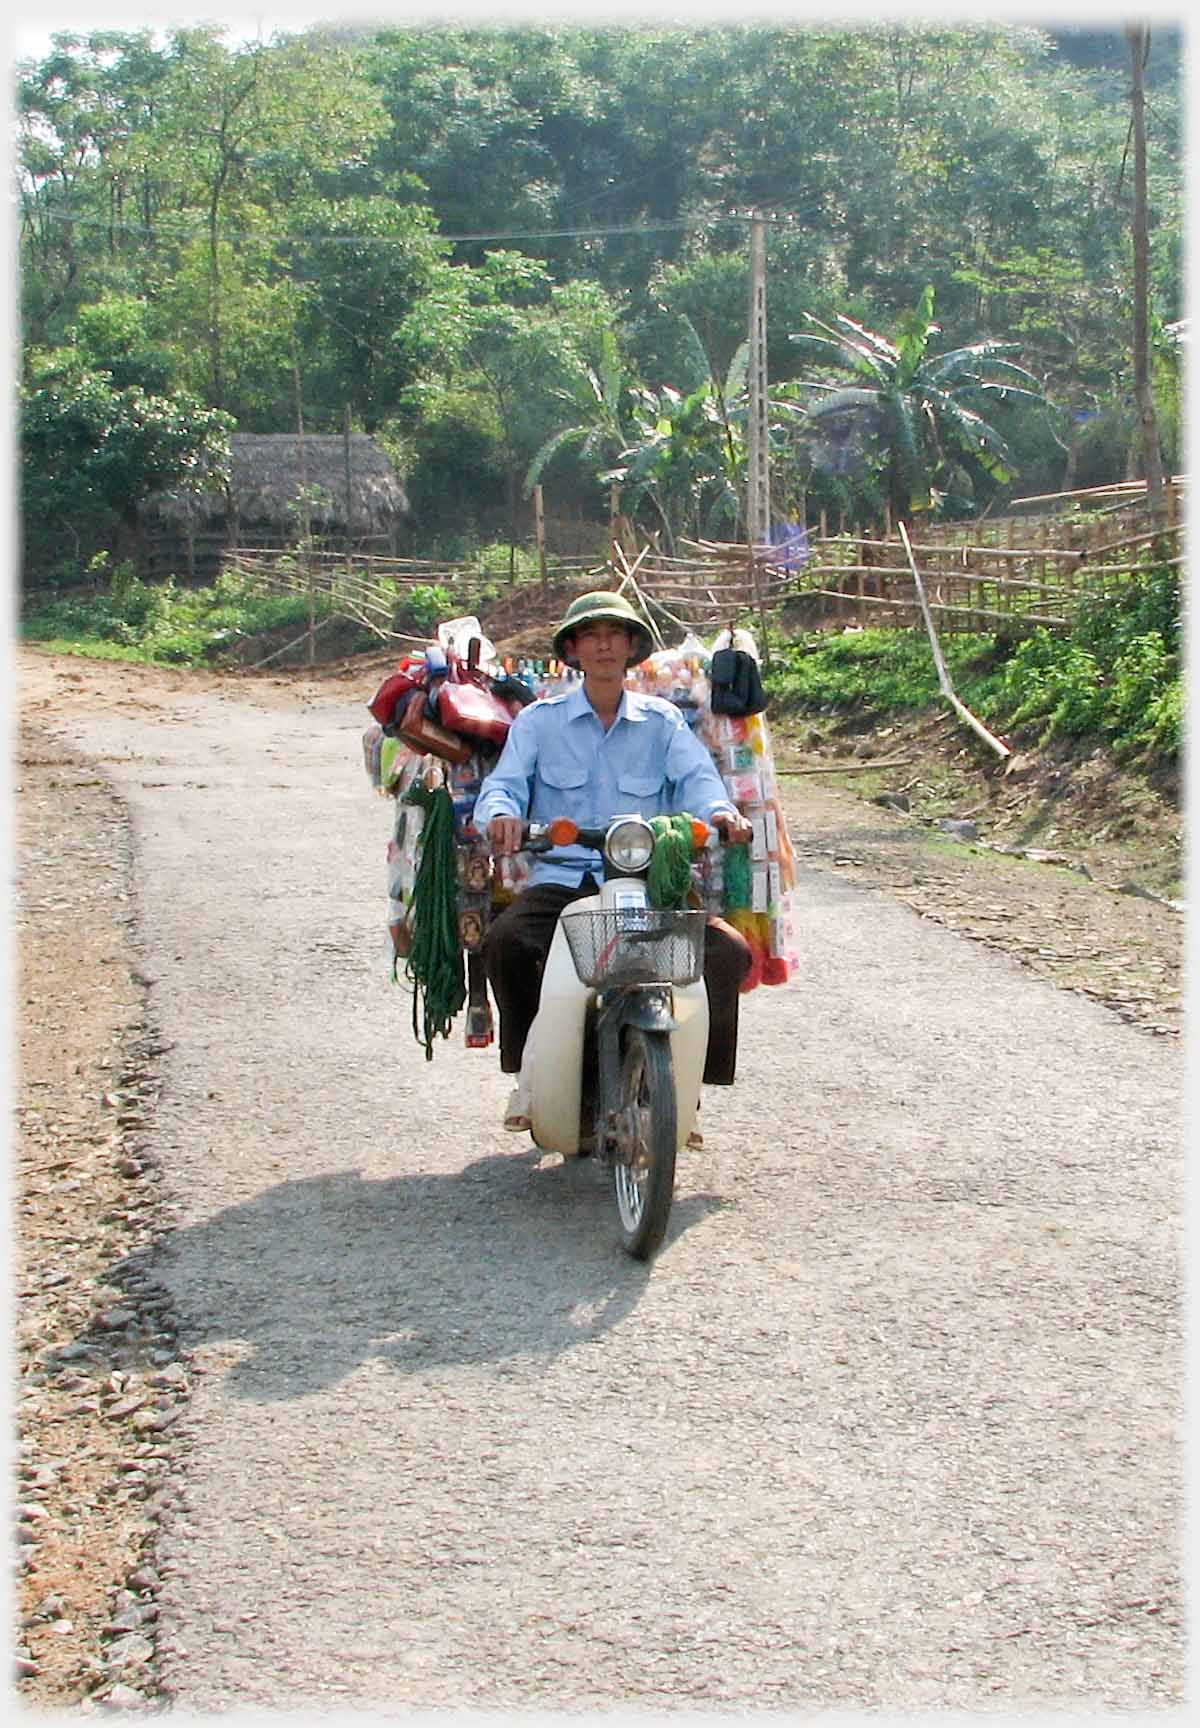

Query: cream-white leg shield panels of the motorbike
left=522, top=878, right=709, bottom=1158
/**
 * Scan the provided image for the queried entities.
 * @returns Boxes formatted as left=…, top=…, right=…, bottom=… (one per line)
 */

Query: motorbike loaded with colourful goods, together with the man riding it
left=363, top=591, right=795, bottom=1258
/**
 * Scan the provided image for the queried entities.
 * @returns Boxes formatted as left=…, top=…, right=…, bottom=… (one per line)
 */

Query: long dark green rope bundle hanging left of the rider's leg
left=403, top=781, right=467, bottom=1063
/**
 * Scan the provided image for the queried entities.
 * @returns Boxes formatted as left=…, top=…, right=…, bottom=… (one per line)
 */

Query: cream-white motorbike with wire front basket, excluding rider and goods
left=520, top=816, right=718, bottom=1260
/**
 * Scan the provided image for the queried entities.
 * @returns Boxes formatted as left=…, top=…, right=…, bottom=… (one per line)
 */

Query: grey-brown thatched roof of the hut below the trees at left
left=147, top=432, right=408, bottom=534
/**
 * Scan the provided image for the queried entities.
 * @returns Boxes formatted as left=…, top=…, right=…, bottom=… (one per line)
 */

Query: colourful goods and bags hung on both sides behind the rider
left=363, top=617, right=799, bottom=1056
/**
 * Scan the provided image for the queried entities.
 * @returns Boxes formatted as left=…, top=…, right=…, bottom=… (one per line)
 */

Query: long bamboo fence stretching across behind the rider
left=223, top=479, right=1184, bottom=641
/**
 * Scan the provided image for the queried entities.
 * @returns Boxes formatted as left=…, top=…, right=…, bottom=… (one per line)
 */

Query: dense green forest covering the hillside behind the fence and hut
left=17, top=24, right=1184, bottom=577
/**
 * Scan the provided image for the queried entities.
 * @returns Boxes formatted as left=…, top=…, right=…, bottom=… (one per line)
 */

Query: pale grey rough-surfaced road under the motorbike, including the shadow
left=16, top=663, right=1184, bottom=1714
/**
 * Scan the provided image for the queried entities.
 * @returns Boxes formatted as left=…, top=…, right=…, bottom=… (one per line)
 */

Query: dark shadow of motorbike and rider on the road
left=108, top=1149, right=723, bottom=1400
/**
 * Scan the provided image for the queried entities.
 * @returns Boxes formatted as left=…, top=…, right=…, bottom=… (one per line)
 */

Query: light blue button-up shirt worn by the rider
left=474, top=684, right=737, bottom=888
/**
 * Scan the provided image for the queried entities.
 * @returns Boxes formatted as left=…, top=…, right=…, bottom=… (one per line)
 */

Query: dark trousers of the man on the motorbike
left=484, top=876, right=752, bottom=1085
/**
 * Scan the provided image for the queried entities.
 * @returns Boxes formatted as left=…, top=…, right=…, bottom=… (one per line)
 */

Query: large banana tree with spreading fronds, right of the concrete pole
left=792, top=287, right=1046, bottom=522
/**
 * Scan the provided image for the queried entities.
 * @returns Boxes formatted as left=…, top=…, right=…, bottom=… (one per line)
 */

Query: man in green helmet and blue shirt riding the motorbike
left=474, top=593, right=752, bottom=1128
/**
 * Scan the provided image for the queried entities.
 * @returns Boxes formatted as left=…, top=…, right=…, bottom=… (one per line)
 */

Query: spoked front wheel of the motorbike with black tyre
left=612, top=1026, right=676, bottom=1260
